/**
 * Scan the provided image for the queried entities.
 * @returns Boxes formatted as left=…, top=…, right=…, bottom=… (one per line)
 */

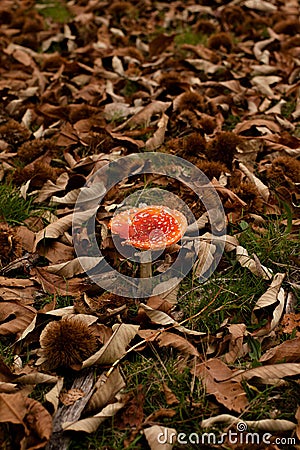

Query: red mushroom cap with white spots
left=109, top=205, right=187, bottom=250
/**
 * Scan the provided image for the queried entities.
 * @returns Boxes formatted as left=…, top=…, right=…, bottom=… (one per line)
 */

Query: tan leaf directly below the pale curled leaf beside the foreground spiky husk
left=86, top=368, right=126, bottom=412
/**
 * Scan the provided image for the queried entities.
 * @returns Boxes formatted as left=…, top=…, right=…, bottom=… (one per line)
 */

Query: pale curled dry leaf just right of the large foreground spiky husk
left=82, top=323, right=139, bottom=368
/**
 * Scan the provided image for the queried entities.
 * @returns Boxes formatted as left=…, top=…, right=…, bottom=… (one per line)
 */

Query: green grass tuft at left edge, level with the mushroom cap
left=0, top=184, right=33, bottom=224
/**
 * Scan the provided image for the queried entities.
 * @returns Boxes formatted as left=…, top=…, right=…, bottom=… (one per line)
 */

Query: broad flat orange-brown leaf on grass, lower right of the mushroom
left=192, top=358, right=248, bottom=413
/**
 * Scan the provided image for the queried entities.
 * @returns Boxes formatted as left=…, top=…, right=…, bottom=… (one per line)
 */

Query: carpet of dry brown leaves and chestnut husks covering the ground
left=0, top=0, right=300, bottom=450
